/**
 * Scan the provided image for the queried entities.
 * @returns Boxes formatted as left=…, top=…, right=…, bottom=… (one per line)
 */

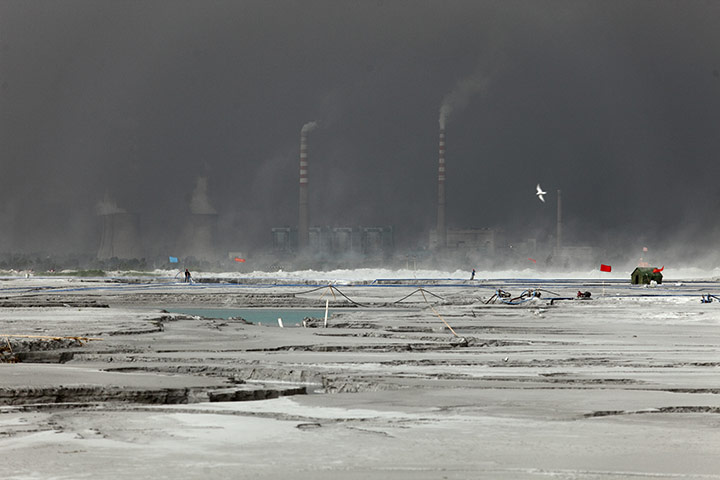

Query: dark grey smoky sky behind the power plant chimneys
left=0, top=0, right=720, bottom=262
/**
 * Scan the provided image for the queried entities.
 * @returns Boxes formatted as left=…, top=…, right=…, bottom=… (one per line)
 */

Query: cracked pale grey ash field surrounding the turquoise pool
left=0, top=274, right=720, bottom=479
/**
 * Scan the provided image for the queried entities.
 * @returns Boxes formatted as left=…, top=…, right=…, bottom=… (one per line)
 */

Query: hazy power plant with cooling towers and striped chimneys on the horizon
left=97, top=122, right=580, bottom=268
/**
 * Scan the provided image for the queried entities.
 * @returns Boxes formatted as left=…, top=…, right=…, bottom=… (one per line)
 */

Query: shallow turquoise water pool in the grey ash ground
left=166, top=308, right=332, bottom=326
